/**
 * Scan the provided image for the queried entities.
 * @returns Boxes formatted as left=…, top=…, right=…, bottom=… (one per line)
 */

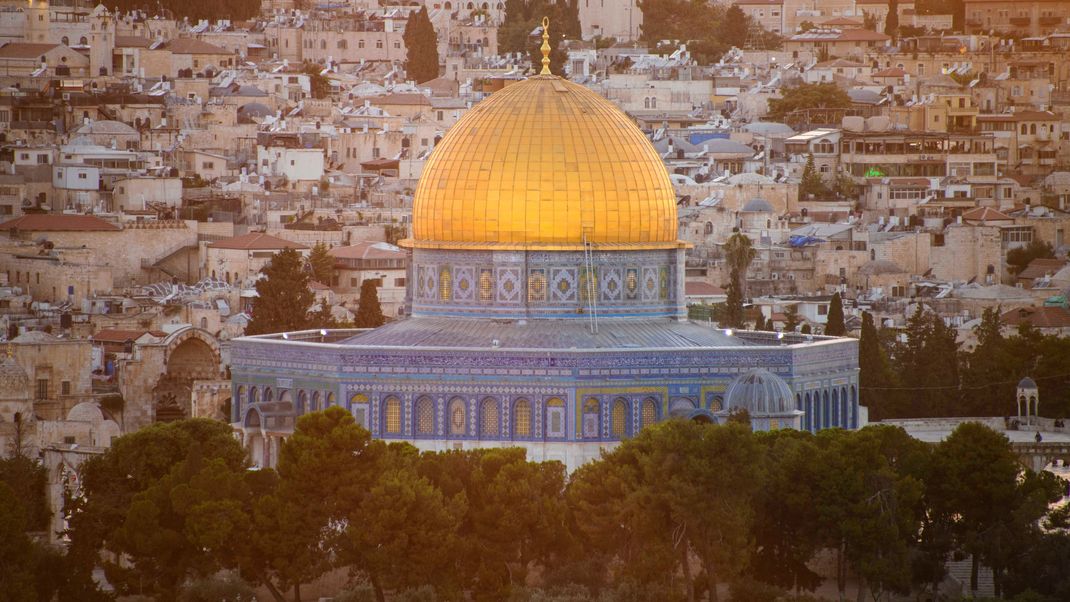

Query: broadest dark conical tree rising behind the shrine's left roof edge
left=245, top=249, right=316, bottom=335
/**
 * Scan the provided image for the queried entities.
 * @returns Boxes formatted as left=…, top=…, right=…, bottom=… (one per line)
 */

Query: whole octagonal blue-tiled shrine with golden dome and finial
left=231, top=24, right=859, bottom=469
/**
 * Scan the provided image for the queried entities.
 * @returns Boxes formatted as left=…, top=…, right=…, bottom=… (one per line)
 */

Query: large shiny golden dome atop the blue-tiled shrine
left=406, top=75, right=683, bottom=249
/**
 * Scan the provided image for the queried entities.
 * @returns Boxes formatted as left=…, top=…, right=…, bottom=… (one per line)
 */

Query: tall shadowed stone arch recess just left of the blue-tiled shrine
left=152, top=328, right=219, bottom=422
